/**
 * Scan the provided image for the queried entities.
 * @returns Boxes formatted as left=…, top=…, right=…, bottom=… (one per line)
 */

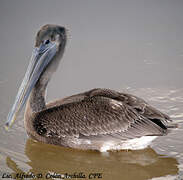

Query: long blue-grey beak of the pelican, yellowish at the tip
left=5, top=42, right=57, bottom=130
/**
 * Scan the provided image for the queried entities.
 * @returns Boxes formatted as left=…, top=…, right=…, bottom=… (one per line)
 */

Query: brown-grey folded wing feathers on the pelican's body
left=33, top=89, right=169, bottom=139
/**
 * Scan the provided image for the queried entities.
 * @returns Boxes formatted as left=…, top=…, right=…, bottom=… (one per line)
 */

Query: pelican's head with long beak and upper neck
left=5, top=24, right=67, bottom=129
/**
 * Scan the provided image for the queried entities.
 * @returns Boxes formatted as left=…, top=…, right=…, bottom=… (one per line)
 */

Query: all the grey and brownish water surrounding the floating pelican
left=0, top=0, right=183, bottom=180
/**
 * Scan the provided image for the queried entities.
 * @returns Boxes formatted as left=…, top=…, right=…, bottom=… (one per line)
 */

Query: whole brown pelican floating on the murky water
left=6, top=25, right=174, bottom=151
